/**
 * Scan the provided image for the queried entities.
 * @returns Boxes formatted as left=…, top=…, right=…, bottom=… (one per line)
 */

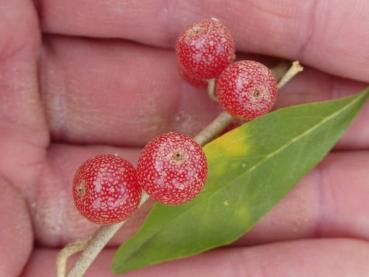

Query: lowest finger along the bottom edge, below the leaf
left=25, top=239, right=369, bottom=277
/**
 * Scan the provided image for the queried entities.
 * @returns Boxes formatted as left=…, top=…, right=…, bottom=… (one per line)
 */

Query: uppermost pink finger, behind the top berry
left=39, top=0, right=369, bottom=81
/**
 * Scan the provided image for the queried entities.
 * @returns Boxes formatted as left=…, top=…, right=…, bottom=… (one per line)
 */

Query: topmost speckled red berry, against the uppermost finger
left=176, top=18, right=235, bottom=80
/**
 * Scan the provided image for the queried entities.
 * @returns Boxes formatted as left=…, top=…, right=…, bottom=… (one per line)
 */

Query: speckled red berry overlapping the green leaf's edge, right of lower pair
left=137, top=132, right=208, bottom=205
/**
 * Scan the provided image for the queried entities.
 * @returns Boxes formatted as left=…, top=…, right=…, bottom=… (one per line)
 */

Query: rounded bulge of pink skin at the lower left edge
left=0, top=177, right=33, bottom=276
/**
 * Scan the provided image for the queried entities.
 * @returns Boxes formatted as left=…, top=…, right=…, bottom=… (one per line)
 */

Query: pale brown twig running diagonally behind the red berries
left=57, top=61, right=303, bottom=277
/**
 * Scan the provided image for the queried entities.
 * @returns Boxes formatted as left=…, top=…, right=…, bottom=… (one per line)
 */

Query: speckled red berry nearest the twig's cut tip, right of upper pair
left=216, top=60, right=277, bottom=120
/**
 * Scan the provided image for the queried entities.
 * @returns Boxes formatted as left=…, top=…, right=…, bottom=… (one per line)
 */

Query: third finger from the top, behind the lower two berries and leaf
left=33, top=145, right=369, bottom=246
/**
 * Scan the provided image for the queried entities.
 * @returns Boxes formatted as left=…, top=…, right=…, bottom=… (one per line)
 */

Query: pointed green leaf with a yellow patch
left=112, top=89, right=369, bottom=273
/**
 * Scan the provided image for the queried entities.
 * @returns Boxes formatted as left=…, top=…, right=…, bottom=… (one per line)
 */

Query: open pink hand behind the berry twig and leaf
left=0, top=0, right=369, bottom=277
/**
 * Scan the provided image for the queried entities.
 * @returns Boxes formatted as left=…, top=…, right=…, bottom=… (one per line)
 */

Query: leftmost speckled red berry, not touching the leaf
left=73, top=154, right=141, bottom=224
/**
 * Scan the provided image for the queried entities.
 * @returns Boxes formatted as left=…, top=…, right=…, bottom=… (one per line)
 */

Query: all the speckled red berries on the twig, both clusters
left=73, top=18, right=277, bottom=224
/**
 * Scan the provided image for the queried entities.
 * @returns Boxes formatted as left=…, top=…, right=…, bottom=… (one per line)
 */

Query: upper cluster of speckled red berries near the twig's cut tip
left=176, top=18, right=277, bottom=120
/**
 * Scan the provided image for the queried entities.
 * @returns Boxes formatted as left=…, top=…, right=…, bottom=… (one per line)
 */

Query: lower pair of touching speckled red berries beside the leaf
left=73, top=132, right=208, bottom=224
